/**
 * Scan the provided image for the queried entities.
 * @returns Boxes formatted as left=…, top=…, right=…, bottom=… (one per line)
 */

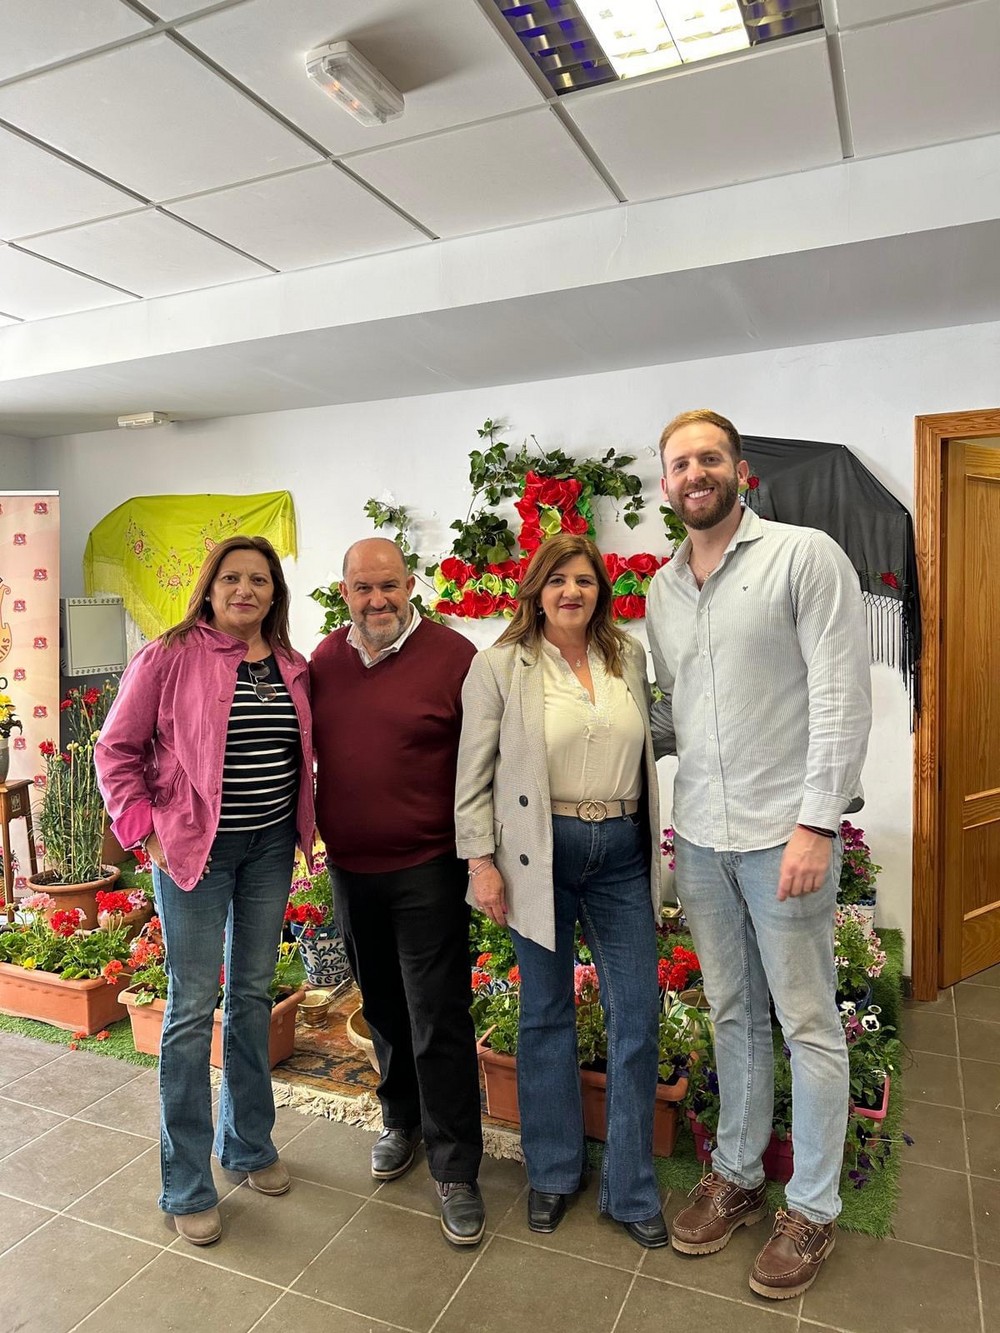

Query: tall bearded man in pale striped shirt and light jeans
left=647, top=411, right=871, bottom=1300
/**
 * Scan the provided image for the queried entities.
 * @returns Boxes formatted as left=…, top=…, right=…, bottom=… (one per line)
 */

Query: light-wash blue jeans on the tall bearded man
left=675, top=837, right=849, bottom=1222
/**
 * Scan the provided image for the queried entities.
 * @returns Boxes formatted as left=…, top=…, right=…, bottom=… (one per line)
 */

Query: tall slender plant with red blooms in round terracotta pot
left=28, top=680, right=119, bottom=928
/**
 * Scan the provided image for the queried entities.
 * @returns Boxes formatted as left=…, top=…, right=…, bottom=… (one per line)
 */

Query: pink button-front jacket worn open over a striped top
left=93, top=624, right=315, bottom=889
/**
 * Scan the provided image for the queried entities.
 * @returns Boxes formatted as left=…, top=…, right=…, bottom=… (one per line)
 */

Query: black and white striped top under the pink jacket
left=219, top=656, right=301, bottom=833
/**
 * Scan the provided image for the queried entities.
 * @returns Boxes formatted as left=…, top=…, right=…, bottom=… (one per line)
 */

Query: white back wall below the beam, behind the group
left=32, top=312, right=1000, bottom=970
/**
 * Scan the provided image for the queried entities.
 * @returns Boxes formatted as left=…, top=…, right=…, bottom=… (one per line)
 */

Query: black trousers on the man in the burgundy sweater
left=331, top=856, right=483, bottom=1181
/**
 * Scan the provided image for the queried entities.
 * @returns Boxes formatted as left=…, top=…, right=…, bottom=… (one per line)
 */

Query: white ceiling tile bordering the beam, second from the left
left=23, top=208, right=268, bottom=297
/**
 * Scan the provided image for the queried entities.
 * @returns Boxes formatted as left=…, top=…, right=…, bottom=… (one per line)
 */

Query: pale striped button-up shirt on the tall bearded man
left=647, top=509, right=872, bottom=852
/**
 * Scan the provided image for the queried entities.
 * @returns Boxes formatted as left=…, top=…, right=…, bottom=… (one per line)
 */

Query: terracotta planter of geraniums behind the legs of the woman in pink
left=119, top=917, right=305, bottom=1069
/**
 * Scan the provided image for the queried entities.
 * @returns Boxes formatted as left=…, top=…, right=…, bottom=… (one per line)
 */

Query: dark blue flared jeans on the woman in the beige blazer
left=511, top=814, right=660, bottom=1222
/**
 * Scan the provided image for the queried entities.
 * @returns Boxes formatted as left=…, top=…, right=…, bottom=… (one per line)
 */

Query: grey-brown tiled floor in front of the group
left=0, top=968, right=1000, bottom=1333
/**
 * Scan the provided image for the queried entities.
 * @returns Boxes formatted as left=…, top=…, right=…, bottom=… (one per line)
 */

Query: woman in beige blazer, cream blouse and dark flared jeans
left=456, top=533, right=667, bottom=1248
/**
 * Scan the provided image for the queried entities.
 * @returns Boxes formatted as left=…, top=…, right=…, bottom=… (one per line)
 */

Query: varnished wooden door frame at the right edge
left=911, top=408, right=1000, bottom=1000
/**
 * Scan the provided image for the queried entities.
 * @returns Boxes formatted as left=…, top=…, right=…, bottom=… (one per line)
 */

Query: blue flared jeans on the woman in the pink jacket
left=153, top=817, right=295, bottom=1214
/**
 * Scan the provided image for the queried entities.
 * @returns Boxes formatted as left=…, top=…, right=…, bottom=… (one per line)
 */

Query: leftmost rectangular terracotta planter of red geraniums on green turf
left=0, top=893, right=129, bottom=1034
